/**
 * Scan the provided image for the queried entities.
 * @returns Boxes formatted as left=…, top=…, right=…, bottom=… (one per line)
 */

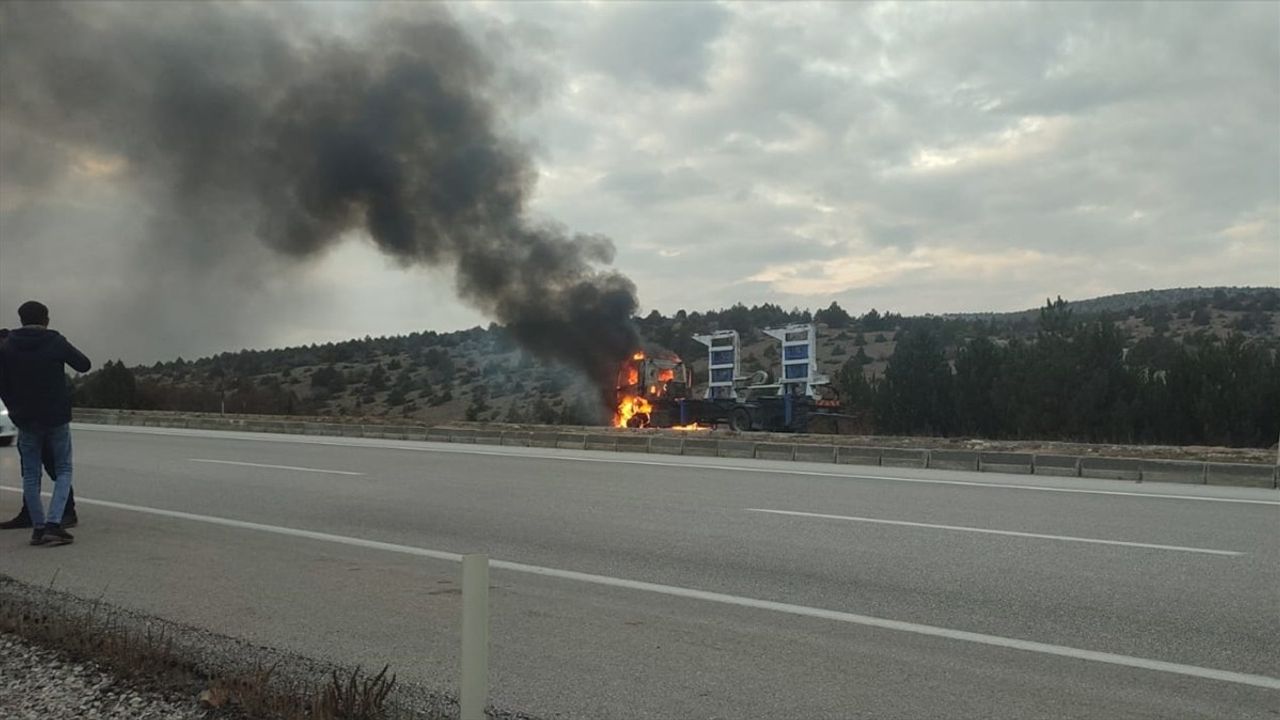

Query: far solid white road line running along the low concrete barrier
left=77, top=424, right=1280, bottom=506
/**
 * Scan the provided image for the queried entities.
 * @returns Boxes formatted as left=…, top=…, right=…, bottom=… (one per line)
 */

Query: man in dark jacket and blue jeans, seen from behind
left=0, top=300, right=90, bottom=544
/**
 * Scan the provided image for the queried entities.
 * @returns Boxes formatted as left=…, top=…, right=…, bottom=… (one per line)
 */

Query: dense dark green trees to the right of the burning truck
left=837, top=295, right=1280, bottom=447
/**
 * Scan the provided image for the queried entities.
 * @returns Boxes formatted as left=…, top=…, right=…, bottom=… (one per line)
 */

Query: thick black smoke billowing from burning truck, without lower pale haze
left=0, top=3, right=639, bottom=399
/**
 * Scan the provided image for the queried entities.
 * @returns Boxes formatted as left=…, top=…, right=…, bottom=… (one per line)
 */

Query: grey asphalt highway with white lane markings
left=0, top=427, right=1280, bottom=719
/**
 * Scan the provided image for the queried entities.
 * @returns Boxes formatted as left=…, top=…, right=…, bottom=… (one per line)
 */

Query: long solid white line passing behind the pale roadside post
left=0, top=486, right=1280, bottom=691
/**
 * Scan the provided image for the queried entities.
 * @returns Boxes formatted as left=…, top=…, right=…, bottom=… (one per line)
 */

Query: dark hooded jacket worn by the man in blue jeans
left=0, top=325, right=90, bottom=428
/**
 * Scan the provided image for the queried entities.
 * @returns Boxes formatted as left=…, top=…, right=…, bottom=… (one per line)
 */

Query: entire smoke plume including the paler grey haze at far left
left=0, top=3, right=636, bottom=392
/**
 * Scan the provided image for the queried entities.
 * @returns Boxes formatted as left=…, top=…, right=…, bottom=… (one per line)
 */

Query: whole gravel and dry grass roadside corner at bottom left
left=0, top=573, right=536, bottom=720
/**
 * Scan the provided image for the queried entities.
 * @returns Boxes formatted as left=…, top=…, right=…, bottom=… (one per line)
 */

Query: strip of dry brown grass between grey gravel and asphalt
left=0, top=575, right=530, bottom=720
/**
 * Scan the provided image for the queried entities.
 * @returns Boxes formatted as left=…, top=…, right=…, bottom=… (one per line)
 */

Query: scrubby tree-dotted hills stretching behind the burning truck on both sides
left=76, top=288, right=1280, bottom=447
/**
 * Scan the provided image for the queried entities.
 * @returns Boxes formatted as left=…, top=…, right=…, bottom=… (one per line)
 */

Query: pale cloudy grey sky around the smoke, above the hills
left=0, top=3, right=1280, bottom=361
